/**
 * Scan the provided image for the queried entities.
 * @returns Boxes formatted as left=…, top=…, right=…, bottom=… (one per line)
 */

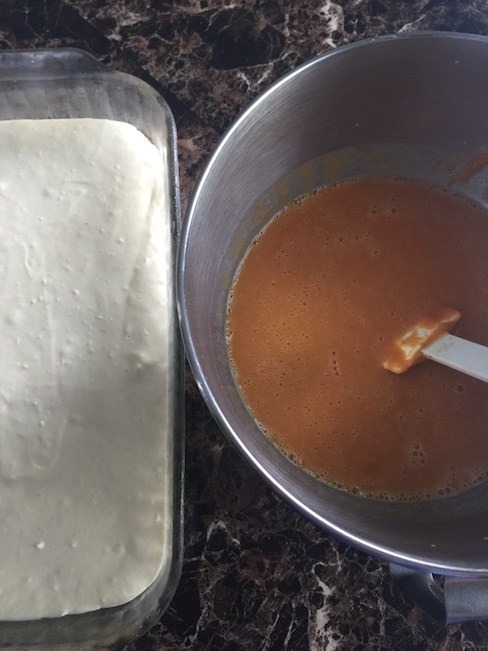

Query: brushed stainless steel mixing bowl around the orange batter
left=177, top=32, right=488, bottom=620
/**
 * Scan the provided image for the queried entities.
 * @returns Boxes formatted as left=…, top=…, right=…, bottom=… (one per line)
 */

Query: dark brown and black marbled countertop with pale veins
left=0, top=0, right=488, bottom=651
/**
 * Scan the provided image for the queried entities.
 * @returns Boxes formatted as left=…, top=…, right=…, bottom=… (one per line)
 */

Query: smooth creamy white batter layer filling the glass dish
left=0, top=119, right=171, bottom=620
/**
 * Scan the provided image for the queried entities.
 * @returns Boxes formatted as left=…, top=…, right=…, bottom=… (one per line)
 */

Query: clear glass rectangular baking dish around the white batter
left=0, top=49, right=184, bottom=649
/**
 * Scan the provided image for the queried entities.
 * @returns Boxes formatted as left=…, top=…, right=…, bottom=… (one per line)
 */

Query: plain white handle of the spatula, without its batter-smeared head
left=422, top=334, right=488, bottom=382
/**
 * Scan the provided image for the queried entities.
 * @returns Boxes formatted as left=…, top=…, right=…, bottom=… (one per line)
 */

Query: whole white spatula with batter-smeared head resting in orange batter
left=383, top=308, right=488, bottom=382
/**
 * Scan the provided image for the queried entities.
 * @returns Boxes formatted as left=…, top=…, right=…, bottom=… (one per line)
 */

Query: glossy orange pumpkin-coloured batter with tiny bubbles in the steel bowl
left=227, top=178, right=488, bottom=499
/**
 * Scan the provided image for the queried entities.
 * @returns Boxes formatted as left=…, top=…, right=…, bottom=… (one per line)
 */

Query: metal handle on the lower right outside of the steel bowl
left=390, top=563, right=488, bottom=625
